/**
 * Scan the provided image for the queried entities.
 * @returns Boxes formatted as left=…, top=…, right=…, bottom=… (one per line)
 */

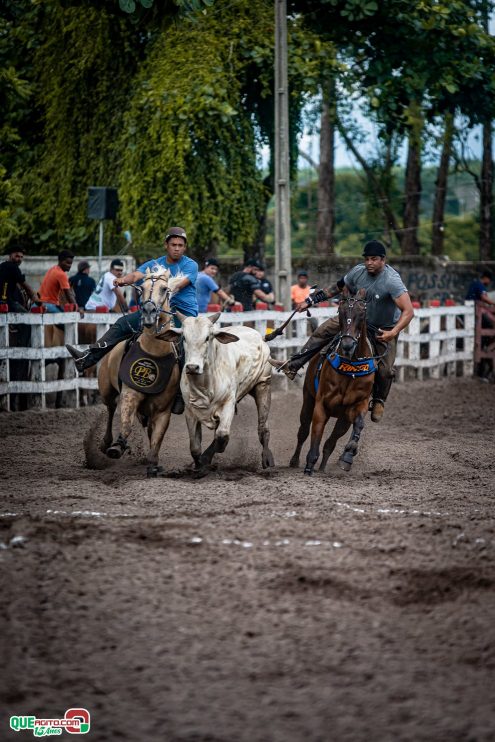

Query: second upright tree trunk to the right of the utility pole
left=401, top=126, right=421, bottom=255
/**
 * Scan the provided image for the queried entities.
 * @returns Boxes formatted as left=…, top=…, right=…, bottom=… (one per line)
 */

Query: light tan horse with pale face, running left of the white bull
left=98, top=268, right=184, bottom=476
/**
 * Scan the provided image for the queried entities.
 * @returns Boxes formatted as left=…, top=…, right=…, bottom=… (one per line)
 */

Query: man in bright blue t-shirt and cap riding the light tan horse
left=65, top=227, right=198, bottom=414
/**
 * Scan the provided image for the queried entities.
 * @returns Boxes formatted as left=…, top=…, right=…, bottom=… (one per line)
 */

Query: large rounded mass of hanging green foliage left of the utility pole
left=120, top=3, right=272, bottom=250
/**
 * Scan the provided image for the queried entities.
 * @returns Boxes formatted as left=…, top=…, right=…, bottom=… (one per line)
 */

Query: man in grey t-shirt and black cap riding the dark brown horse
left=270, top=240, right=414, bottom=422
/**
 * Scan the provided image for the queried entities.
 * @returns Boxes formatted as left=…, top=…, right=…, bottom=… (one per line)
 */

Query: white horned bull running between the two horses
left=164, top=314, right=274, bottom=473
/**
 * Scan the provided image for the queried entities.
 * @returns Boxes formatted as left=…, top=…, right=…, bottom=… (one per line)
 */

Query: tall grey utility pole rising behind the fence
left=275, top=0, right=292, bottom=311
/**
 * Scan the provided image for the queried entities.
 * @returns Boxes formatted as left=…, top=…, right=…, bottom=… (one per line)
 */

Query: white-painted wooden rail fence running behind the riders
left=0, top=302, right=475, bottom=410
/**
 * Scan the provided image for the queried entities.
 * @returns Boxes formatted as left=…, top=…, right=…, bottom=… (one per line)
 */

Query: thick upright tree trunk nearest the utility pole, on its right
left=316, top=82, right=335, bottom=255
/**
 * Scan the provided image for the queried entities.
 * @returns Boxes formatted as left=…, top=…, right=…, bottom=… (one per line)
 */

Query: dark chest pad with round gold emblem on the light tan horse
left=119, top=342, right=176, bottom=394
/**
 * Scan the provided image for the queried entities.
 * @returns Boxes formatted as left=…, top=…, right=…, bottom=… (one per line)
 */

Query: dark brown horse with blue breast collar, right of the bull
left=290, top=289, right=376, bottom=475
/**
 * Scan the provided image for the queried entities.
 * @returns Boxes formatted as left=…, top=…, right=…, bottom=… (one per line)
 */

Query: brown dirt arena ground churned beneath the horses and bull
left=0, top=379, right=495, bottom=742
